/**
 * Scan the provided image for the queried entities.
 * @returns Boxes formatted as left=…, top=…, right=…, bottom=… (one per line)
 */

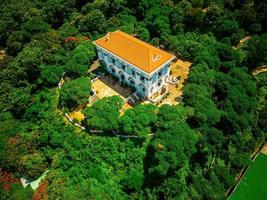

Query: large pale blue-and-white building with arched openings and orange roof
left=94, top=30, right=175, bottom=102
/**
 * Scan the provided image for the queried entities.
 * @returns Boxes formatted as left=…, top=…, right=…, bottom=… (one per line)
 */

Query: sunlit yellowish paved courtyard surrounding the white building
left=69, top=59, right=192, bottom=121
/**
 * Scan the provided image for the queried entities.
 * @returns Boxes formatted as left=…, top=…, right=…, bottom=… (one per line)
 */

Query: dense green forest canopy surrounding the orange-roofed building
left=0, top=0, right=267, bottom=199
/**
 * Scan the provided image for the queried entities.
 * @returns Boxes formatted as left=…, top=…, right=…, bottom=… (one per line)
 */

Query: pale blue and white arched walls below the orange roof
left=97, top=46, right=170, bottom=96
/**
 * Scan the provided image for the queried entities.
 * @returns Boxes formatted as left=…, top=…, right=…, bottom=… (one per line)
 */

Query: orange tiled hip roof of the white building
left=94, top=30, right=175, bottom=73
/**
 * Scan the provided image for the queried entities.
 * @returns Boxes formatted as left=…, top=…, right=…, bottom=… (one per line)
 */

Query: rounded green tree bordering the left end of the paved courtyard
left=60, top=77, right=91, bottom=110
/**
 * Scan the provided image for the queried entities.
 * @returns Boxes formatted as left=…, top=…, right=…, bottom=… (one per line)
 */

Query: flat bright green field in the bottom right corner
left=229, top=153, right=267, bottom=200
